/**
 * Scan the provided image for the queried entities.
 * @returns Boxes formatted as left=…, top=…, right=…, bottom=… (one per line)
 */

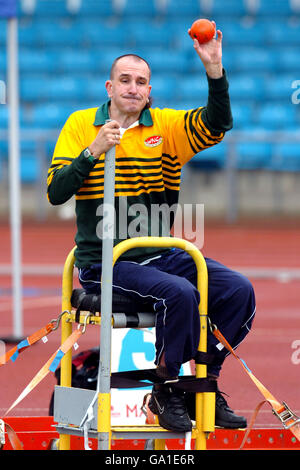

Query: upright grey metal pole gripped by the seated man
left=97, top=142, right=116, bottom=450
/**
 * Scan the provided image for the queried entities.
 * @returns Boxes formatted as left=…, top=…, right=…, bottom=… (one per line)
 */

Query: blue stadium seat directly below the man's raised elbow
left=189, top=142, right=227, bottom=171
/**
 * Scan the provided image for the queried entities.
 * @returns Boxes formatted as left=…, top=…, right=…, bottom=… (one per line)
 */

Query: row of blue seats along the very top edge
left=20, top=0, right=299, bottom=18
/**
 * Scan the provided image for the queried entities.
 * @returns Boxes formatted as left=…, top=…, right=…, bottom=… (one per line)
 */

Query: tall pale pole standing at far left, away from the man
left=7, top=18, right=23, bottom=338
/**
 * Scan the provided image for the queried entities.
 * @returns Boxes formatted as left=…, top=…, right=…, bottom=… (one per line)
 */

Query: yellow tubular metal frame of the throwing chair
left=59, top=237, right=215, bottom=450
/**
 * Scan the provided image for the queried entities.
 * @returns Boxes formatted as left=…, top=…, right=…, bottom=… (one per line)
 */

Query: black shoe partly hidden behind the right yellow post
left=185, top=390, right=247, bottom=429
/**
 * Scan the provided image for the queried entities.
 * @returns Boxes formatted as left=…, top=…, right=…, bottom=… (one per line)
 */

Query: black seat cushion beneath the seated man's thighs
left=71, top=289, right=154, bottom=313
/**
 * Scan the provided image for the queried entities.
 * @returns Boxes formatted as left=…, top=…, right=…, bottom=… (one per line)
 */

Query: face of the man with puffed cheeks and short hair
left=105, top=57, right=151, bottom=115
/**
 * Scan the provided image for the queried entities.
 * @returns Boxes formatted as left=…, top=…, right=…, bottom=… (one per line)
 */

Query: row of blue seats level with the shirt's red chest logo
left=0, top=141, right=300, bottom=184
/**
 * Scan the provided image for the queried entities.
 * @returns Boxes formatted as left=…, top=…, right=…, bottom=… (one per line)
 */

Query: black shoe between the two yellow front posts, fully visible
left=148, top=385, right=192, bottom=432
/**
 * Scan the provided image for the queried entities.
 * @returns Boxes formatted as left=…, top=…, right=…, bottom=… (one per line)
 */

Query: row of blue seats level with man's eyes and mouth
left=9, top=72, right=300, bottom=106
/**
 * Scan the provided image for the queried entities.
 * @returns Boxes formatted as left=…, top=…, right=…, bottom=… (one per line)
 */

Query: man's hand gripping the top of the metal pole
left=89, top=121, right=121, bottom=158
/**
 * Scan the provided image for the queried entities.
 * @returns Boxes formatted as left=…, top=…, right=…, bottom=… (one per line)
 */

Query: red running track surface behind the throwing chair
left=0, top=222, right=300, bottom=427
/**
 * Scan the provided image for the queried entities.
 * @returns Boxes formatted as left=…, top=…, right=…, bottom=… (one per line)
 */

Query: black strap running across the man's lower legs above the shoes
left=111, top=369, right=217, bottom=393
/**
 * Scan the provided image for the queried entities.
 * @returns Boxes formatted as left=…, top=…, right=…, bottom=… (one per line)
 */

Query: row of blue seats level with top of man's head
left=0, top=46, right=300, bottom=75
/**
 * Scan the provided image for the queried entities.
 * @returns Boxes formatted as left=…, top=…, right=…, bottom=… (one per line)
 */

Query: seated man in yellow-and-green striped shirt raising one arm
left=48, top=23, right=255, bottom=431
